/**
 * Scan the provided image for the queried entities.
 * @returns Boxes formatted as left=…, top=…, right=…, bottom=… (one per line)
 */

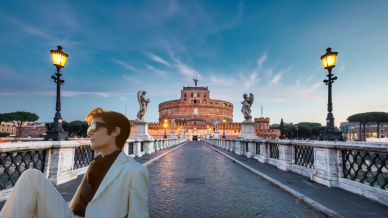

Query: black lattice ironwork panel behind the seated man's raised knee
left=0, top=150, right=46, bottom=190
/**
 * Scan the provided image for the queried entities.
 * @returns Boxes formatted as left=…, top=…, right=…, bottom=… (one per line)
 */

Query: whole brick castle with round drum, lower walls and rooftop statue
left=136, top=79, right=280, bottom=139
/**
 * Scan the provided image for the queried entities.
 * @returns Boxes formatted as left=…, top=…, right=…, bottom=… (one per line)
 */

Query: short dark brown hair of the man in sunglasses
left=85, top=108, right=131, bottom=149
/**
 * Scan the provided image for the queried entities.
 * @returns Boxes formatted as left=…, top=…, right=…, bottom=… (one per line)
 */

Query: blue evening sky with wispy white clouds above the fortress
left=0, top=0, right=388, bottom=125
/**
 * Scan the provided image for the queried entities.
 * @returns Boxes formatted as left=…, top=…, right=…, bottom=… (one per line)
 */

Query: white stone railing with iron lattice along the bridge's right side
left=205, top=139, right=388, bottom=206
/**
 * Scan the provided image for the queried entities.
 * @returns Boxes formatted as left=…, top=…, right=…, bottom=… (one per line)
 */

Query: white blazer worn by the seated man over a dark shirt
left=81, top=152, right=149, bottom=218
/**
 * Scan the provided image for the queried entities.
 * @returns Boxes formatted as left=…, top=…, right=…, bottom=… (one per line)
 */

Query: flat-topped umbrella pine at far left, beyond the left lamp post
left=4, top=111, right=39, bottom=137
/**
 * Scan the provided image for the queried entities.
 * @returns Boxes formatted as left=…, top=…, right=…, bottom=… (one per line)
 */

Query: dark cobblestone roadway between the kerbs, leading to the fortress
left=149, top=142, right=320, bottom=217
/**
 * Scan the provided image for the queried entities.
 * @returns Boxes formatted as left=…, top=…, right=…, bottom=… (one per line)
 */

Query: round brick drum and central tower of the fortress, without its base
left=159, top=86, right=233, bottom=124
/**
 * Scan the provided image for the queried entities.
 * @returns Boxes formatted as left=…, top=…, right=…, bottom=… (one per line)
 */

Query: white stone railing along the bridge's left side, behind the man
left=0, top=139, right=185, bottom=201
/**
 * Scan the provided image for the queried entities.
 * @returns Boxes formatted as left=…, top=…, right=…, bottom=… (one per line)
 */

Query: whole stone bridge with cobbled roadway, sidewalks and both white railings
left=0, top=138, right=388, bottom=217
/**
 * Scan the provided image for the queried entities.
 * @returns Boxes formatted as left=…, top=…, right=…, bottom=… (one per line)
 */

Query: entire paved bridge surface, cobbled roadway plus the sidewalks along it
left=0, top=142, right=388, bottom=217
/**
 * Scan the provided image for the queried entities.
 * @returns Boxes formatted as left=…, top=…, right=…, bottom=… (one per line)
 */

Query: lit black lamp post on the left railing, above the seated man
left=45, top=46, right=69, bottom=141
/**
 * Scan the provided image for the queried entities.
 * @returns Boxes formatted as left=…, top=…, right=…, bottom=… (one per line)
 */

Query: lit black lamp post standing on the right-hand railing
left=319, top=48, right=342, bottom=141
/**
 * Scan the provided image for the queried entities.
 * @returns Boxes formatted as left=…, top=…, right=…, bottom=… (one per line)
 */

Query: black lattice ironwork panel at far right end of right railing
left=342, top=150, right=388, bottom=190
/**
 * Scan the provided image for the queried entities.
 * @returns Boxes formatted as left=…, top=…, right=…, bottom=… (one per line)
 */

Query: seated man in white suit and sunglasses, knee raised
left=0, top=108, right=149, bottom=218
